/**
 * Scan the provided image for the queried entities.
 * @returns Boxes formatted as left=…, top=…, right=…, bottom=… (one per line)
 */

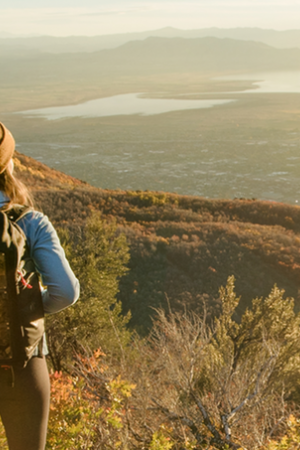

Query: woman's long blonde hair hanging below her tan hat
left=0, top=170, right=33, bottom=209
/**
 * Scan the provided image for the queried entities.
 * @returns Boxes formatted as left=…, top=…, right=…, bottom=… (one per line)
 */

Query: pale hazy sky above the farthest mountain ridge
left=0, top=0, right=300, bottom=36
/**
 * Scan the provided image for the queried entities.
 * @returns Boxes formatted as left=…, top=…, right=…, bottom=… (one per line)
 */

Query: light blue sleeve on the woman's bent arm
left=18, top=211, right=79, bottom=314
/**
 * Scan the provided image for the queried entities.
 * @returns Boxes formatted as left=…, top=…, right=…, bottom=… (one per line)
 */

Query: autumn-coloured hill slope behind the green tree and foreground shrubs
left=16, top=154, right=300, bottom=333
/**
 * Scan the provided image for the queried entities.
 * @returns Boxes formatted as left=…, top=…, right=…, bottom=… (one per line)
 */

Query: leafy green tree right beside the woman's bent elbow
left=47, top=213, right=130, bottom=370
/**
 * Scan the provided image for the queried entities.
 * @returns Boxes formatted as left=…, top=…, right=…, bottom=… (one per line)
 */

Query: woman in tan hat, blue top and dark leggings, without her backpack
left=0, top=122, right=79, bottom=450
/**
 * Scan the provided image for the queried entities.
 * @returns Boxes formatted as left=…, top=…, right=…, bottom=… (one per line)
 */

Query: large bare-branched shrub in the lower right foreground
left=135, top=277, right=300, bottom=449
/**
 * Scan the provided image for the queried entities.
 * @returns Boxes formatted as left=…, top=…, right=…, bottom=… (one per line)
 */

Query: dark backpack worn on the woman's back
left=0, top=206, right=44, bottom=368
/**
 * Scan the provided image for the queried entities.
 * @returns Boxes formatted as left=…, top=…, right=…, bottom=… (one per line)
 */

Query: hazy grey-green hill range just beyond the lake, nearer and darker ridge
left=0, top=37, right=300, bottom=86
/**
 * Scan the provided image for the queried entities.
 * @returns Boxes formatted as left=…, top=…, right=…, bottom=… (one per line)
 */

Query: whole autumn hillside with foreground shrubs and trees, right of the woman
left=9, top=153, right=300, bottom=450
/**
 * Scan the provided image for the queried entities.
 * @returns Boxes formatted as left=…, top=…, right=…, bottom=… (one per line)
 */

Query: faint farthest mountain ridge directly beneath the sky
left=0, top=27, right=300, bottom=55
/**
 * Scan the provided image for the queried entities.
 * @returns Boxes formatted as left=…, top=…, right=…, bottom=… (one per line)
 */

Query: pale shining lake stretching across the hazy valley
left=17, top=71, right=300, bottom=120
